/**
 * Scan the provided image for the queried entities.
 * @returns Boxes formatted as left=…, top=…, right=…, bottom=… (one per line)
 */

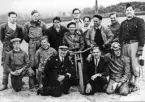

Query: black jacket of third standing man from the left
left=46, top=26, right=68, bottom=51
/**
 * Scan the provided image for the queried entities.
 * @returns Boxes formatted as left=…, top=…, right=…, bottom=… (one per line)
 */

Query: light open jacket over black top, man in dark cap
left=85, top=26, right=114, bottom=46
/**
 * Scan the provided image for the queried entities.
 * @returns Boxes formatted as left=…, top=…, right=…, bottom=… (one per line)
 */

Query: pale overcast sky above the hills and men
left=0, top=0, right=145, bottom=14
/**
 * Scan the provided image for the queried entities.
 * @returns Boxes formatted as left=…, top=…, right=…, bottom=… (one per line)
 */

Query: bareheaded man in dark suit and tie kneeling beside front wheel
left=84, top=47, right=109, bottom=95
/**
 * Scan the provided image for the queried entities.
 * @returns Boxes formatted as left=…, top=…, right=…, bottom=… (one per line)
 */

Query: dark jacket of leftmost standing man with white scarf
left=0, top=23, right=24, bottom=44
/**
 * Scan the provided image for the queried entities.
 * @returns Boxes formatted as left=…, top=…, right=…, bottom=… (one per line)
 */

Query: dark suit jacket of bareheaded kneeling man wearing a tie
left=84, top=57, right=109, bottom=84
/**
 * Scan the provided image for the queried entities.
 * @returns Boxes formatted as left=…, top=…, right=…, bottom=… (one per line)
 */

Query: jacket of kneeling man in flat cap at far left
left=6, top=50, right=30, bottom=71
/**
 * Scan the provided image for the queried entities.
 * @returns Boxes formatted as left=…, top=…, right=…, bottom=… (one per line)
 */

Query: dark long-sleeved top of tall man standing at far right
left=119, top=17, right=145, bottom=47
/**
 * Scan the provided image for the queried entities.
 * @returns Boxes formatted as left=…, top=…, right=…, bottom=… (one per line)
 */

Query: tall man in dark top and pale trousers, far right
left=119, top=3, right=145, bottom=92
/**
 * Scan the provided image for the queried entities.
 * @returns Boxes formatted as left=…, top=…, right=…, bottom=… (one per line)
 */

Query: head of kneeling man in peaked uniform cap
left=58, top=44, right=68, bottom=57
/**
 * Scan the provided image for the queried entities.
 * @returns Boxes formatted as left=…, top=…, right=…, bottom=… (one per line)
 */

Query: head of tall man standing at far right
left=126, top=3, right=134, bottom=18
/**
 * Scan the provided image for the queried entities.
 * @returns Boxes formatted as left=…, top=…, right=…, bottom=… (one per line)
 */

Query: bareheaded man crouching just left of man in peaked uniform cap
left=35, top=36, right=57, bottom=87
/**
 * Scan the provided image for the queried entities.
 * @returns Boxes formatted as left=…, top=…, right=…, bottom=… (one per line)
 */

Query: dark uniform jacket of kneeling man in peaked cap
left=44, top=56, right=71, bottom=86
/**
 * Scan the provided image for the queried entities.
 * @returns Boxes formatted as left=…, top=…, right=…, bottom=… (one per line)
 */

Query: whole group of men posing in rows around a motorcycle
left=0, top=4, right=145, bottom=97
